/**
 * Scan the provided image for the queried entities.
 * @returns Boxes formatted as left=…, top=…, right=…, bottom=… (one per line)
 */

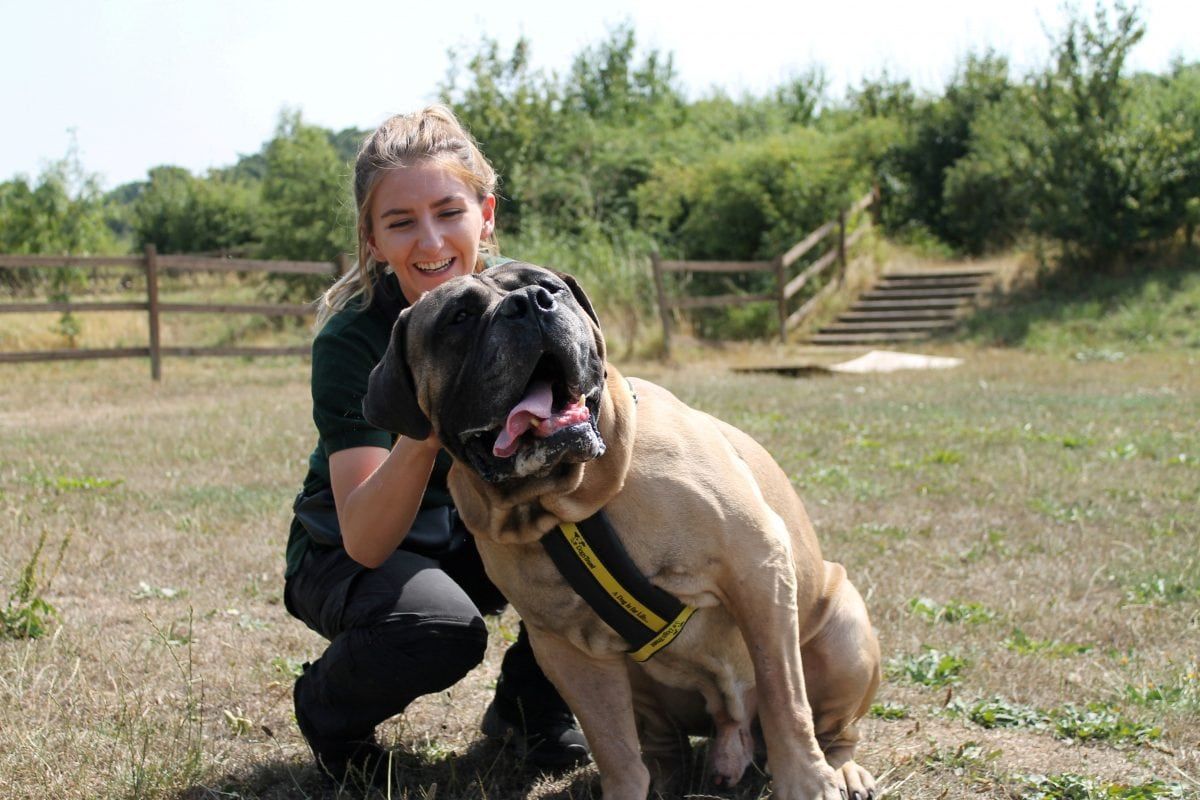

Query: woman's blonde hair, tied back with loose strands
left=317, top=106, right=497, bottom=327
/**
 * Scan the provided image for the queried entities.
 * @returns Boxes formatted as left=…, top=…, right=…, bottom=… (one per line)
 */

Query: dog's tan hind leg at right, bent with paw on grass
left=802, top=563, right=881, bottom=800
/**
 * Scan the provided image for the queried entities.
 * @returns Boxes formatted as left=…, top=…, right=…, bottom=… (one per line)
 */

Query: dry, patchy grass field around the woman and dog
left=0, top=345, right=1200, bottom=800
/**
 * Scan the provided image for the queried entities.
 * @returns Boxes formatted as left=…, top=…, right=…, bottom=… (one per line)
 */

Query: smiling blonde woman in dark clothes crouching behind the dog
left=284, top=106, right=588, bottom=782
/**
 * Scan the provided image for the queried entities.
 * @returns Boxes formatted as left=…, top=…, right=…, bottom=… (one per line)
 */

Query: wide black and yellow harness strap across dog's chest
left=541, top=510, right=696, bottom=661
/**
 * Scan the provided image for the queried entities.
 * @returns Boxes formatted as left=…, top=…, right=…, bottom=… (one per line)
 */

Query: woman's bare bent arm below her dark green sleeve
left=329, top=437, right=442, bottom=569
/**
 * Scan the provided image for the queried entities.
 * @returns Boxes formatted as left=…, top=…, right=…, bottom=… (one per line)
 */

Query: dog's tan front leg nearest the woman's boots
left=526, top=622, right=650, bottom=800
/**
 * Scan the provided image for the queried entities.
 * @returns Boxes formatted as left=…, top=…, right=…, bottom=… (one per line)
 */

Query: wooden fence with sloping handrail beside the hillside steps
left=650, top=187, right=880, bottom=355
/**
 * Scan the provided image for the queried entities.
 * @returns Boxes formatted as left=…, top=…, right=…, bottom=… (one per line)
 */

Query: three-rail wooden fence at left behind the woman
left=0, top=245, right=347, bottom=380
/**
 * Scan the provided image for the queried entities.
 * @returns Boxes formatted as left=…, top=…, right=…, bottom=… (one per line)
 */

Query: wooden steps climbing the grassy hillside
left=809, top=267, right=991, bottom=344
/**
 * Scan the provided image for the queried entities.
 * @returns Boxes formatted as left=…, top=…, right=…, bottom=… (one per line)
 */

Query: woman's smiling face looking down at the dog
left=367, top=163, right=496, bottom=303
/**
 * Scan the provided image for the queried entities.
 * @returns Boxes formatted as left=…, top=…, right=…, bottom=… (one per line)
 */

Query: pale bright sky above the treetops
left=0, top=0, right=1200, bottom=188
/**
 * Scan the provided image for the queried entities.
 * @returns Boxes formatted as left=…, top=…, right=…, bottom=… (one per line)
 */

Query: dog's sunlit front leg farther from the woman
left=728, top=577, right=844, bottom=800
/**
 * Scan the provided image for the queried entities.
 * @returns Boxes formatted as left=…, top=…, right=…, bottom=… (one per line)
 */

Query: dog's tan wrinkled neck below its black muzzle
left=449, top=365, right=636, bottom=545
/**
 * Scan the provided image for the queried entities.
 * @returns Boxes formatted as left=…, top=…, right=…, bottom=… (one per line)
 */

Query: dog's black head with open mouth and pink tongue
left=362, top=263, right=605, bottom=483
